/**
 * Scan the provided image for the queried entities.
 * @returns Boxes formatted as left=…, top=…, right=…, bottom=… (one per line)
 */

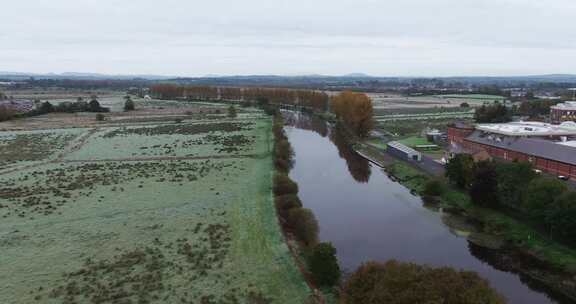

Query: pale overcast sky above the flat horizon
left=0, top=0, right=576, bottom=76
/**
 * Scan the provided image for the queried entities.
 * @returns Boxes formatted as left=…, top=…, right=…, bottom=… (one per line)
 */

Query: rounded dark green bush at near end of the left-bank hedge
left=308, top=243, right=340, bottom=286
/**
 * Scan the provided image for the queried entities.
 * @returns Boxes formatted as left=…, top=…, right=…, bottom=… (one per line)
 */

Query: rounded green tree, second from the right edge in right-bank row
left=523, top=177, right=566, bottom=220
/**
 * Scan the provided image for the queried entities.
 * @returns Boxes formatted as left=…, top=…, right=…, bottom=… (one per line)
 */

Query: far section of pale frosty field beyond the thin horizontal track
left=66, top=119, right=269, bottom=160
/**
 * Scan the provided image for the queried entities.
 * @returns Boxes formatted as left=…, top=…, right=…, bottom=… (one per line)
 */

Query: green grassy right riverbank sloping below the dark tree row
left=376, top=158, right=576, bottom=302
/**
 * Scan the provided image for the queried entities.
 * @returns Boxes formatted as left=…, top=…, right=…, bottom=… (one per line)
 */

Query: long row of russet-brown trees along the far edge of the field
left=150, top=84, right=330, bottom=111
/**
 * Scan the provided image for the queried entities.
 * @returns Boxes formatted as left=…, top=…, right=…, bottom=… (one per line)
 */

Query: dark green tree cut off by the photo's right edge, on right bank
left=546, top=191, right=576, bottom=246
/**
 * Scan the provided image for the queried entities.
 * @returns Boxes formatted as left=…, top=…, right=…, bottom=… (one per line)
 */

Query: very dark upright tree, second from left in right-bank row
left=468, top=161, right=498, bottom=207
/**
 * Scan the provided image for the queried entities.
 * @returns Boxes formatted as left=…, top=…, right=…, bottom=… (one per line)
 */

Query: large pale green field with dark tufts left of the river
left=0, top=110, right=310, bottom=303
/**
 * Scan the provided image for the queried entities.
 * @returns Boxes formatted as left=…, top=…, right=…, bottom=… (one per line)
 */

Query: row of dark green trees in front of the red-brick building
left=444, top=154, right=576, bottom=246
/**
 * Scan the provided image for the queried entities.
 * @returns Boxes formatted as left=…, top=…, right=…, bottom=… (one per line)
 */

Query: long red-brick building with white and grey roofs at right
left=448, top=122, right=576, bottom=179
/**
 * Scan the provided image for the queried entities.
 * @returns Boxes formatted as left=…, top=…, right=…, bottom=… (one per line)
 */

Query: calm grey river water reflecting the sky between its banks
left=284, top=112, right=561, bottom=304
